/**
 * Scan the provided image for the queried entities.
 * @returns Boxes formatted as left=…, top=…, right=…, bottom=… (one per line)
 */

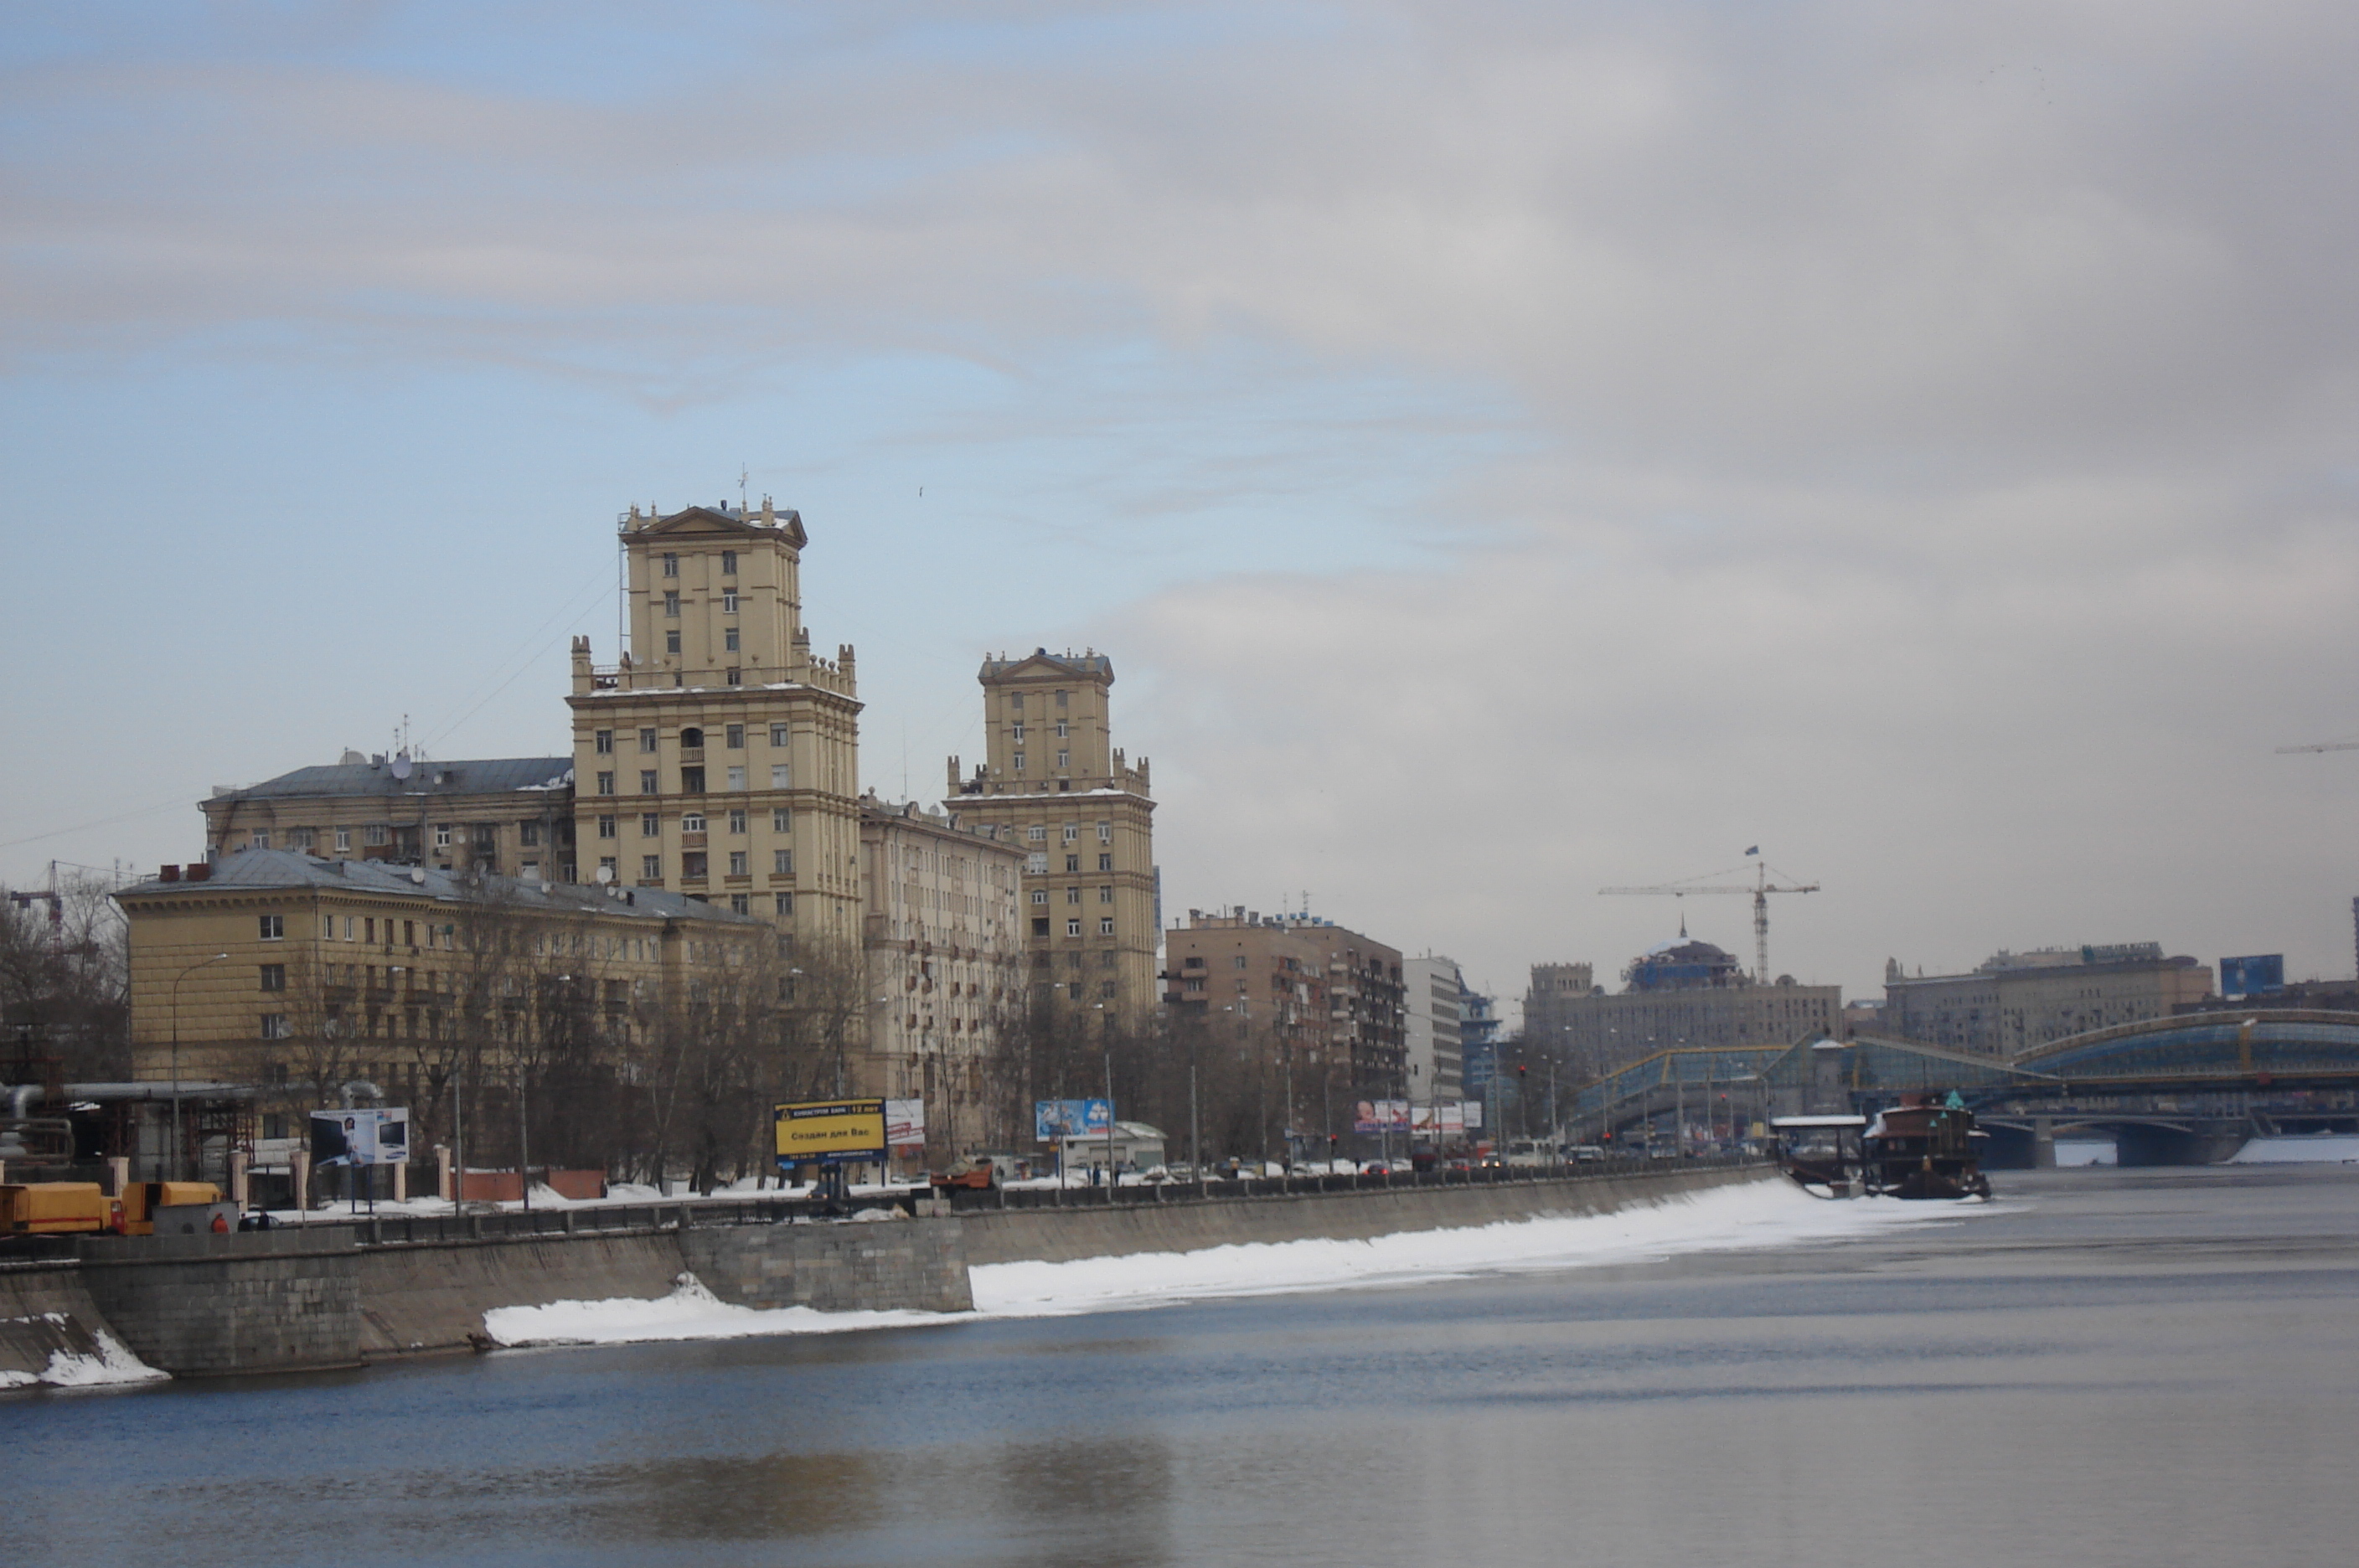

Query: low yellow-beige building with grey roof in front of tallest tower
left=116, top=848, right=769, bottom=1137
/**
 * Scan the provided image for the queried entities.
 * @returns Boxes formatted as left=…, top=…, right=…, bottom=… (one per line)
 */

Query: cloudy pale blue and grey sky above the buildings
left=0, top=0, right=2359, bottom=998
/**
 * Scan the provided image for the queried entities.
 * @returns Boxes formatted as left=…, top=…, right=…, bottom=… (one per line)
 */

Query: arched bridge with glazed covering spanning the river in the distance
left=1569, top=1009, right=2359, bottom=1165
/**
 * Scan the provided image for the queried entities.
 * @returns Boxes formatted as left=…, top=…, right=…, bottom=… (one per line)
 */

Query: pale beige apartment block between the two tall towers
left=854, top=797, right=1024, bottom=1165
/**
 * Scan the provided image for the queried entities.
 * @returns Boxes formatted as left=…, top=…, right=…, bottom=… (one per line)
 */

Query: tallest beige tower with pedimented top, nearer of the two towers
left=566, top=498, right=861, bottom=948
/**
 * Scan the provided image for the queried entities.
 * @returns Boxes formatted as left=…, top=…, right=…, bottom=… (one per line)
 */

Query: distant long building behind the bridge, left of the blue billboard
left=1880, top=941, right=2212, bottom=1059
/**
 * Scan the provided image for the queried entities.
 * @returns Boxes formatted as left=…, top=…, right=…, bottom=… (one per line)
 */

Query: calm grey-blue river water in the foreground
left=0, top=1167, right=2359, bottom=1568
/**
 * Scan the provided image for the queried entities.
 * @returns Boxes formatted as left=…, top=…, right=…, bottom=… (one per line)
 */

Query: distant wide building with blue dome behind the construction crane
left=1524, top=941, right=1842, bottom=1082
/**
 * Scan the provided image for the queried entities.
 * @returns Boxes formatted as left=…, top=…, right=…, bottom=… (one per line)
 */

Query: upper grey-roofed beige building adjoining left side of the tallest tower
left=199, top=752, right=573, bottom=882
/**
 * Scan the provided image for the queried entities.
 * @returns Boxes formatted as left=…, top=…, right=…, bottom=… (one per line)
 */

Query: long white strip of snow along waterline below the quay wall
left=483, top=1179, right=1989, bottom=1344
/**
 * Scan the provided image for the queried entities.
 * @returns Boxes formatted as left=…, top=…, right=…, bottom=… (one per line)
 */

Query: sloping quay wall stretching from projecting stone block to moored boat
left=958, top=1165, right=1772, bottom=1264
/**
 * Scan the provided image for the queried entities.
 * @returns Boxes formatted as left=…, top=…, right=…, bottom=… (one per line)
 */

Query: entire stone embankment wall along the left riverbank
left=0, top=1165, right=1764, bottom=1384
